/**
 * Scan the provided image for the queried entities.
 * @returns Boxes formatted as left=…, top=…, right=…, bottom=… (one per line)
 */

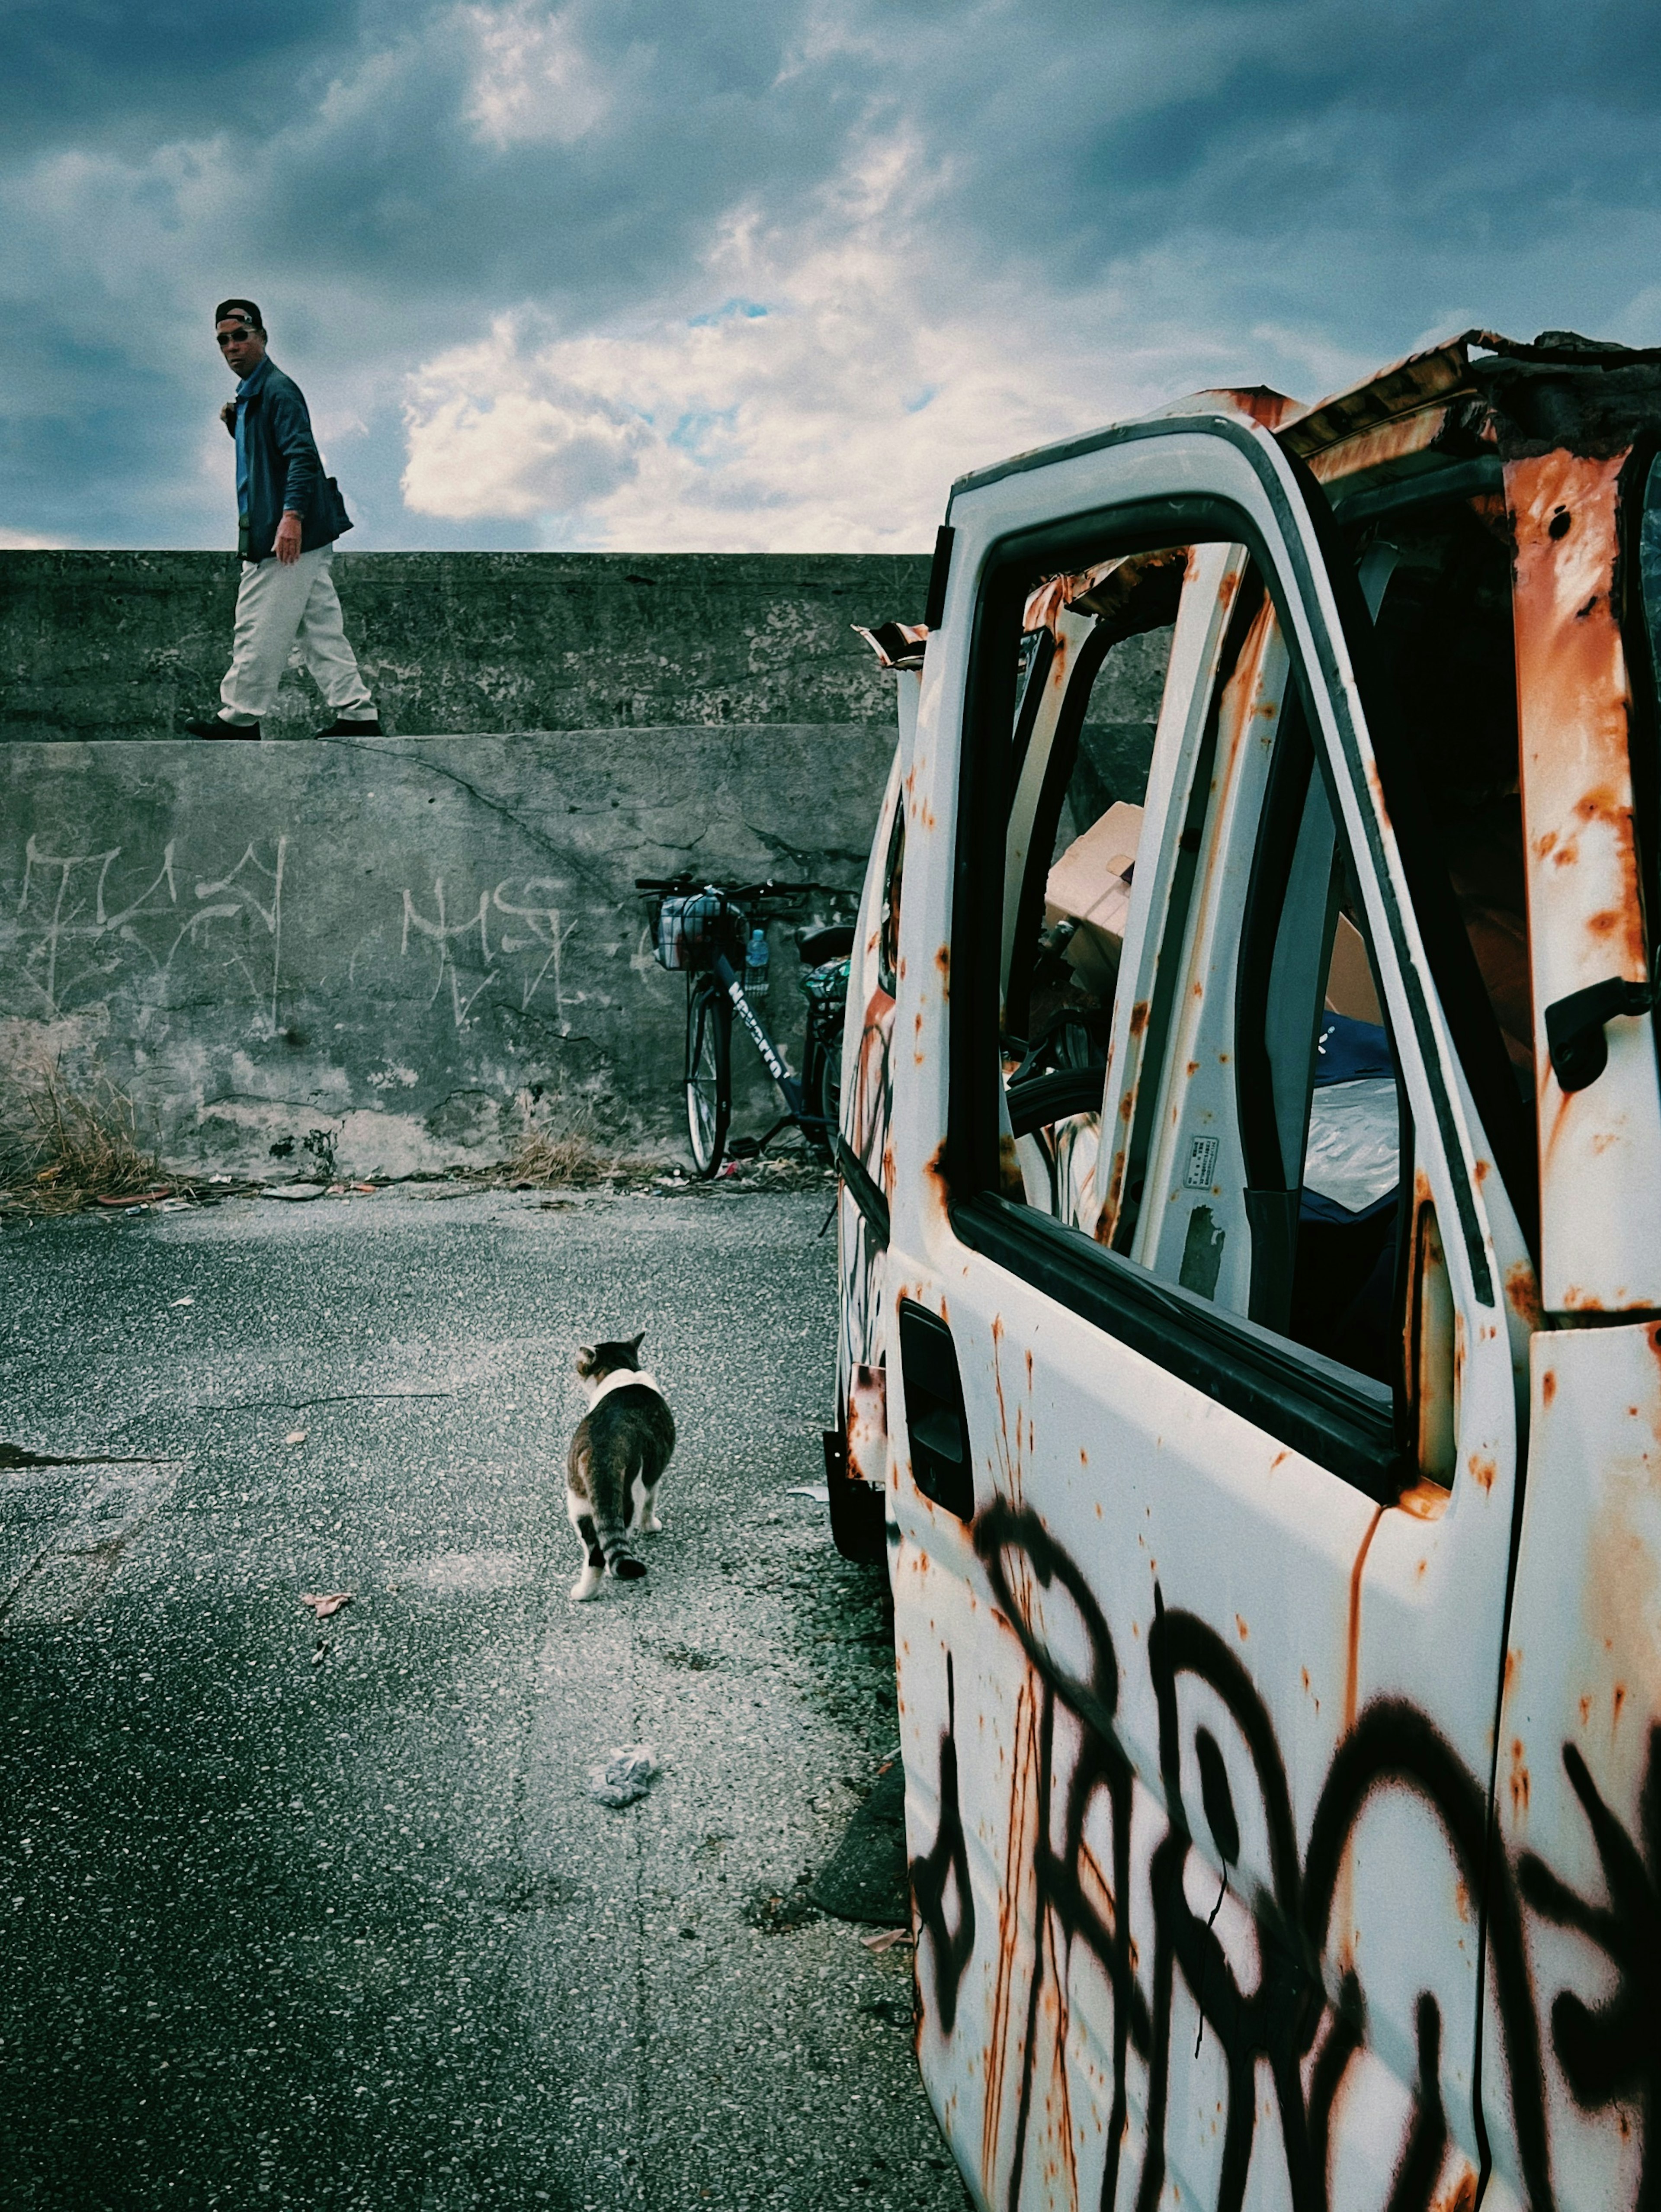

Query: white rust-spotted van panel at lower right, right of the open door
left=1484, top=1323, right=1661, bottom=2212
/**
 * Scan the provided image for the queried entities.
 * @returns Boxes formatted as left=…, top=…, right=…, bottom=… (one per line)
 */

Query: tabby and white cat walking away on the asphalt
left=566, top=1329, right=675, bottom=1604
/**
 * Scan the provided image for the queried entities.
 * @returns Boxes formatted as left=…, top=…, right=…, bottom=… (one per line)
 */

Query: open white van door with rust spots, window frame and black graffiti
left=889, top=405, right=1548, bottom=2212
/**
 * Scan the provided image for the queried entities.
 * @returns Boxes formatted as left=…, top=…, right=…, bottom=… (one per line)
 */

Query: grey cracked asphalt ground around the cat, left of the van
left=0, top=1186, right=964, bottom=2212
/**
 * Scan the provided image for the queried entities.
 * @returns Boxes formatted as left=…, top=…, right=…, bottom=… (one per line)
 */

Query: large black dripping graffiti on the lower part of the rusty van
left=911, top=1500, right=1661, bottom=2212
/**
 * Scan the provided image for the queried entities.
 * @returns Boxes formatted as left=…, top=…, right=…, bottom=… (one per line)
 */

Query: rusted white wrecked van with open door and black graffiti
left=827, top=332, right=1661, bottom=2212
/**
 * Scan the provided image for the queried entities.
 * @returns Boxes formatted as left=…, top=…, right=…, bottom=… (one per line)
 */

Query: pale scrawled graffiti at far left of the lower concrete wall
left=4, top=836, right=288, bottom=1029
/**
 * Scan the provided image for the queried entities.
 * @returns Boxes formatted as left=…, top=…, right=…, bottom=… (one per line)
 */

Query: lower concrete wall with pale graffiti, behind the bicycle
left=0, top=726, right=894, bottom=1177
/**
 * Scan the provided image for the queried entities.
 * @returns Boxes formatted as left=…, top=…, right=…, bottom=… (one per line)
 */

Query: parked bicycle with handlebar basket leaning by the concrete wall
left=635, top=876, right=854, bottom=1179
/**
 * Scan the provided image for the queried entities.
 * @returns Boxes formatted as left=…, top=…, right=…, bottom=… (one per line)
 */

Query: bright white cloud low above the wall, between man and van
left=394, top=146, right=1212, bottom=551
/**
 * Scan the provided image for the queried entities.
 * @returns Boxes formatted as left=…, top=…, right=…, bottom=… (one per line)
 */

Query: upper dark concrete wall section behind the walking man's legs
left=0, top=540, right=929, bottom=748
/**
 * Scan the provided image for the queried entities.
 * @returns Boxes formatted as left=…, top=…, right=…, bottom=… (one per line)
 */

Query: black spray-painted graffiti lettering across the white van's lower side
left=911, top=1500, right=1574, bottom=2212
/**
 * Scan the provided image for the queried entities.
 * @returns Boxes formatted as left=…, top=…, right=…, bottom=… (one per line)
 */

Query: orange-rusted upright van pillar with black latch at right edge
left=1506, top=451, right=1661, bottom=1314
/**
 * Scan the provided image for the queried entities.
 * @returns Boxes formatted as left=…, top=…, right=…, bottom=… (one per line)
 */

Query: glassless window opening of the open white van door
left=953, top=515, right=1477, bottom=1498
